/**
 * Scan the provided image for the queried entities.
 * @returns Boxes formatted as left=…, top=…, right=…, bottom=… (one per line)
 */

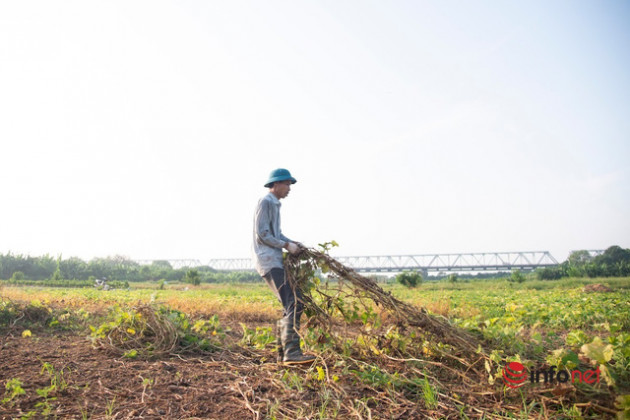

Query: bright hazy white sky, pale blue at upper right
left=0, top=0, right=630, bottom=261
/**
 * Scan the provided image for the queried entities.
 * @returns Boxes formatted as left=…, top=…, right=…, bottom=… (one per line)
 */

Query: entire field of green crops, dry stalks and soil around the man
left=0, top=278, right=630, bottom=419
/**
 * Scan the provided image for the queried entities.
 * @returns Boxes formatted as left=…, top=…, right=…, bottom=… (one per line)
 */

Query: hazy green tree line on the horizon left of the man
left=0, top=253, right=260, bottom=285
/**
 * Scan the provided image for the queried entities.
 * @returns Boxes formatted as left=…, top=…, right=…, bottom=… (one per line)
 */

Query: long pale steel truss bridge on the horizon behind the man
left=136, top=251, right=564, bottom=273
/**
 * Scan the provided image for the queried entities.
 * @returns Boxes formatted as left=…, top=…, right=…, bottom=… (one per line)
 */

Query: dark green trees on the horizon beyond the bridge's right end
left=536, top=245, right=630, bottom=280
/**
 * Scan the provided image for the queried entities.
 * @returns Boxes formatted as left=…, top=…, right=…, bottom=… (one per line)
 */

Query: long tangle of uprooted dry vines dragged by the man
left=285, top=242, right=491, bottom=392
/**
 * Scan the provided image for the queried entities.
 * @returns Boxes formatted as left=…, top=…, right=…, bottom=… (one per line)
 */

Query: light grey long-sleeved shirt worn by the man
left=252, top=193, right=291, bottom=276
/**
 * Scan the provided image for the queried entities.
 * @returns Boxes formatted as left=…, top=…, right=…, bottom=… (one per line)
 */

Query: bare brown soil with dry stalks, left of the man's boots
left=0, top=326, right=303, bottom=419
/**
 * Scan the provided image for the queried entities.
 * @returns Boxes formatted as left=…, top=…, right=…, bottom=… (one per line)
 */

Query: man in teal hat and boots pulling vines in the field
left=253, top=168, right=315, bottom=364
